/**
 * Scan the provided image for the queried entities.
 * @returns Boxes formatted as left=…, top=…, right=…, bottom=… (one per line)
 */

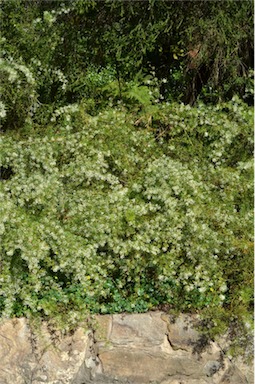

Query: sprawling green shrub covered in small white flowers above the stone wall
left=0, top=100, right=252, bottom=332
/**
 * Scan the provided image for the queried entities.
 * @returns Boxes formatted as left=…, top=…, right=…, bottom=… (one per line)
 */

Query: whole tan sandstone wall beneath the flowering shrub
left=0, top=312, right=253, bottom=384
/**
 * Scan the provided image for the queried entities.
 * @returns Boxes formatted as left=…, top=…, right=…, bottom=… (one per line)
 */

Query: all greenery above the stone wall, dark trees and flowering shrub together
left=0, top=0, right=253, bottom=354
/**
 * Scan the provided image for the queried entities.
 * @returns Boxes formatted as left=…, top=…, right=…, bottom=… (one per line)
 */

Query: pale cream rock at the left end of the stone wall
left=0, top=319, right=91, bottom=384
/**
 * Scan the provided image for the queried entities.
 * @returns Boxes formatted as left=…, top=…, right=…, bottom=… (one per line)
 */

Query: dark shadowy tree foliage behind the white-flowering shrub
left=1, top=0, right=254, bottom=112
